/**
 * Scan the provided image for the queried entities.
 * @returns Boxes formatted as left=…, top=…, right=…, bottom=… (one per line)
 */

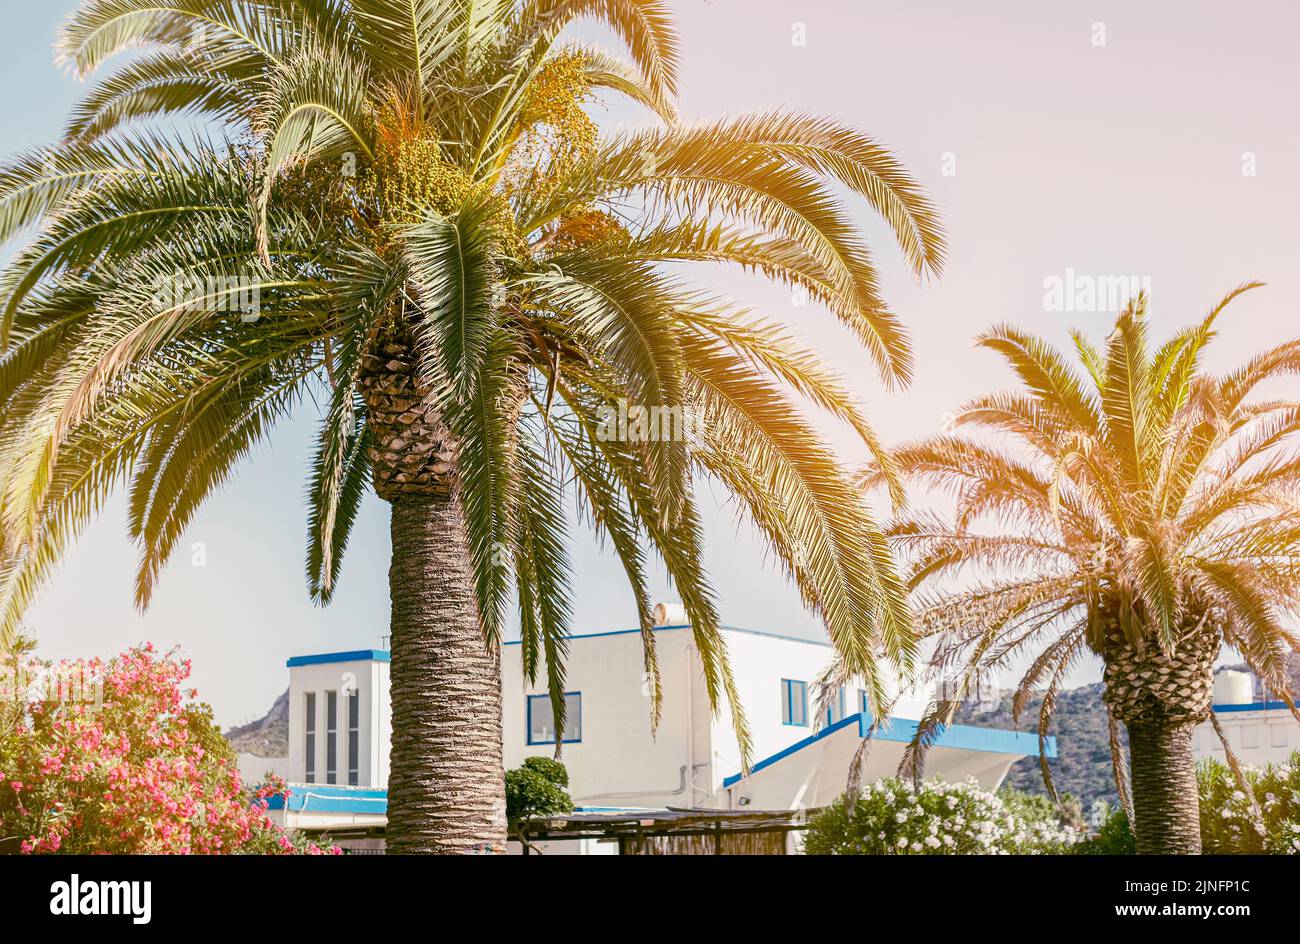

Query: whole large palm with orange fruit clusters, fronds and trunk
left=0, top=0, right=944, bottom=852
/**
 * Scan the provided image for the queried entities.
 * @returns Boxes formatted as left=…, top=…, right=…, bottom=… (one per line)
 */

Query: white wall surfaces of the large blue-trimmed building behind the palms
left=271, top=627, right=1034, bottom=837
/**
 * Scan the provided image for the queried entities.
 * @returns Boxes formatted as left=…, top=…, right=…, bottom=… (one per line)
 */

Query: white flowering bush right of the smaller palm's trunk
left=1196, top=754, right=1300, bottom=856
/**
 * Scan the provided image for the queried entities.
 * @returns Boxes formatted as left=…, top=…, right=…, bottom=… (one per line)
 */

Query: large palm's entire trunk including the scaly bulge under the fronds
left=363, top=326, right=506, bottom=853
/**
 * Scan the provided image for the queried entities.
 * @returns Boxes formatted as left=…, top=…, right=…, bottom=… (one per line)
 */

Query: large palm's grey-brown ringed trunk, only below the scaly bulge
left=387, top=493, right=506, bottom=853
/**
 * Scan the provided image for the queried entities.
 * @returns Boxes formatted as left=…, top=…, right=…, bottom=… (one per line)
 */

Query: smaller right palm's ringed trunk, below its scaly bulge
left=1127, top=719, right=1201, bottom=856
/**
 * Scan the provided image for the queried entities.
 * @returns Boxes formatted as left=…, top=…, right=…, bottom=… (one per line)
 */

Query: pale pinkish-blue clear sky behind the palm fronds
left=0, top=0, right=1300, bottom=724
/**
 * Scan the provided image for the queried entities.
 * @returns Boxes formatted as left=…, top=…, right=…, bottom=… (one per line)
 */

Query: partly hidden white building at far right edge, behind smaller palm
left=1192, top=670, right=1300, bottom=767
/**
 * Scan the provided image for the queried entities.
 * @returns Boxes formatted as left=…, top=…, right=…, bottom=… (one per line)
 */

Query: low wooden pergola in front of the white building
left=523, top=807, right=809, bottom=856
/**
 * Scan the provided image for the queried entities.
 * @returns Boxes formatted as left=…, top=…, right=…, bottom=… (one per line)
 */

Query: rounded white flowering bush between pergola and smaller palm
left=803, top=778, right=1079, bottom=856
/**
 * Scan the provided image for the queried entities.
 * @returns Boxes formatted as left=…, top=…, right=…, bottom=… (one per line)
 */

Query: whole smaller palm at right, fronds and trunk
left=863, top=283, right=1300, bottom=853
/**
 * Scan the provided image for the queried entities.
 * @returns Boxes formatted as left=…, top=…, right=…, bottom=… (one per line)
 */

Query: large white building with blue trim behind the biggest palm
left=248, top=625, right=1056, bottom=852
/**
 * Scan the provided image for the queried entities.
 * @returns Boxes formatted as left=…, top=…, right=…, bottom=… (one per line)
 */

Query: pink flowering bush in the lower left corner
left=0, top=645, right=339, bottom=854
